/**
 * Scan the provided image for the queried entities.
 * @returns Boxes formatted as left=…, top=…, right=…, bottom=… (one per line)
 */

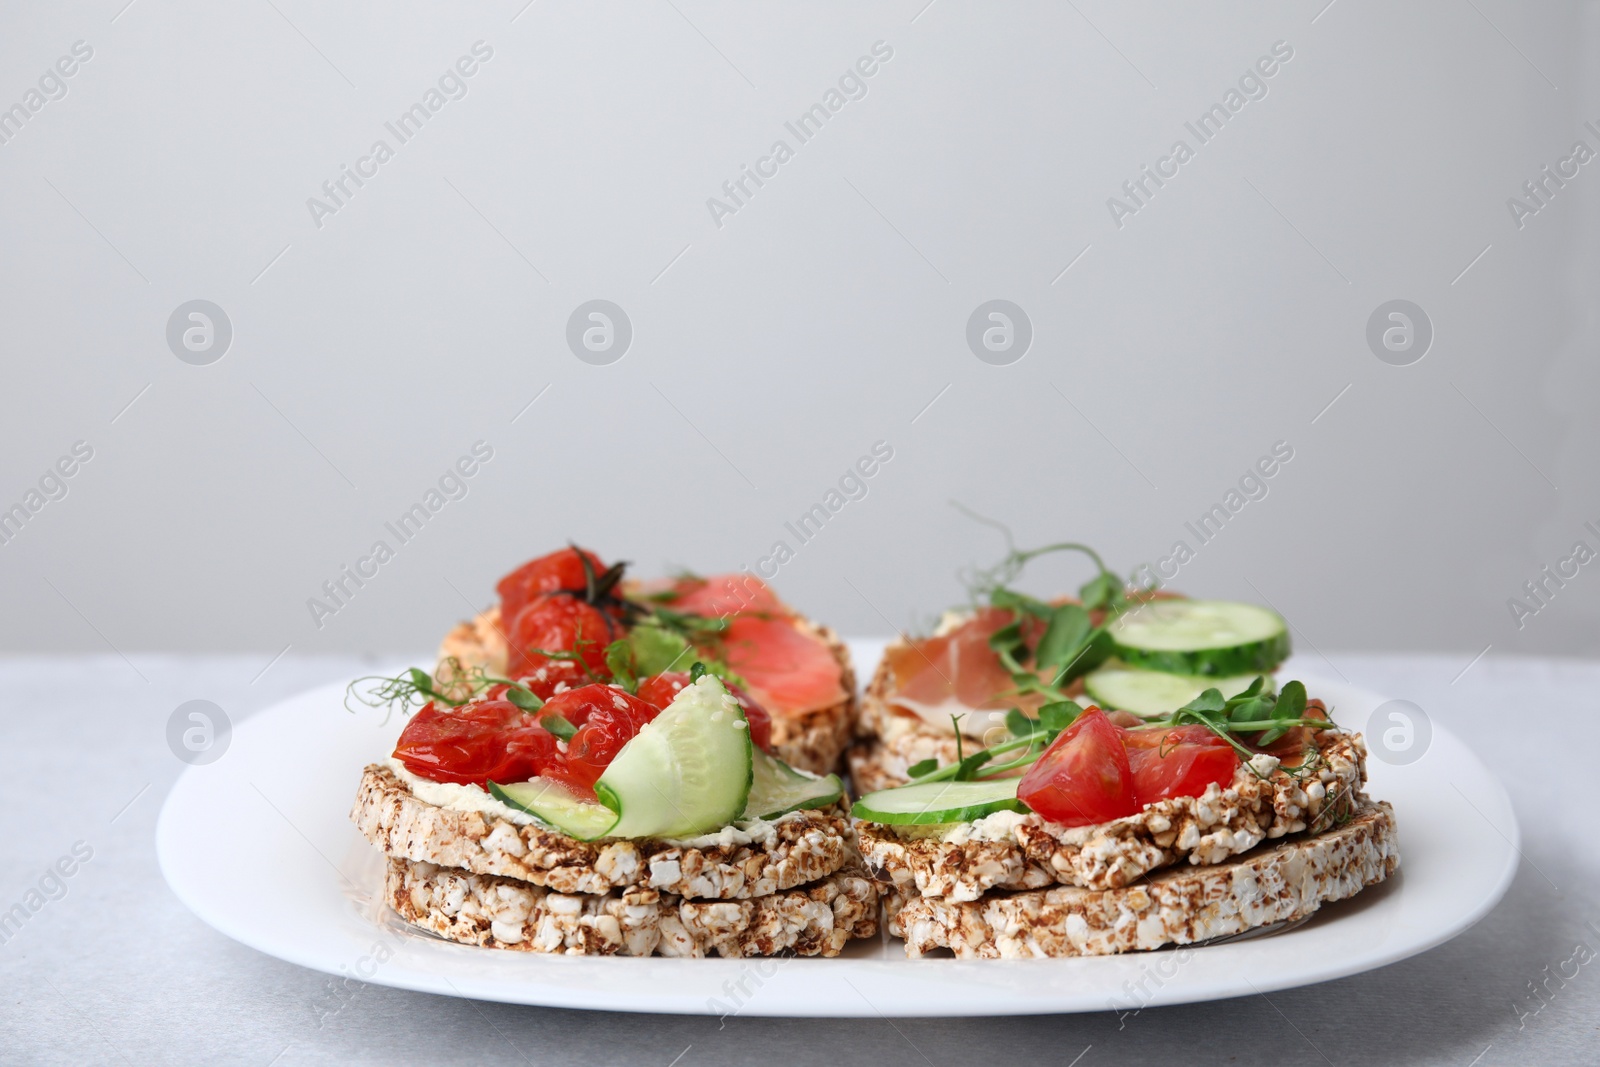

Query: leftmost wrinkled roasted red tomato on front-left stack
left=395, top=701, right=562, bottom=785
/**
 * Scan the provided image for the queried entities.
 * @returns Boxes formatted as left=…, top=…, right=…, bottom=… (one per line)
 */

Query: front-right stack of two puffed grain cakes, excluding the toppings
left=856, top=731, right=1400, bottom=958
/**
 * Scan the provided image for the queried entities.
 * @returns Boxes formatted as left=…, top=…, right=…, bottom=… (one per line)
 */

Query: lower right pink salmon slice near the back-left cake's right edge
left=720, top=614, right=850, bottom=717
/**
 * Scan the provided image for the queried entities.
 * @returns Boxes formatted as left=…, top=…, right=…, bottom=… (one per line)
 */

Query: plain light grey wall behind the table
left=0, top=0, right=1600, bottom=664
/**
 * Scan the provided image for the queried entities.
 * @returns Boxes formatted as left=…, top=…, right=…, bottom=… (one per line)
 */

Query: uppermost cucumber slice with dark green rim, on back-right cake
left=1109, top=600, right=1290, bottom=678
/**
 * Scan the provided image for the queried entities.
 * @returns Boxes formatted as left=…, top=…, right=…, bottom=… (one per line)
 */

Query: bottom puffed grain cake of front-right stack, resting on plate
left=886, top=803, right=1400, bottom=960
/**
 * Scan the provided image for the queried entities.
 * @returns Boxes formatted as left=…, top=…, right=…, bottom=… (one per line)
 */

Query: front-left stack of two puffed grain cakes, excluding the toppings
left=350, top=765, right=878, bottom=957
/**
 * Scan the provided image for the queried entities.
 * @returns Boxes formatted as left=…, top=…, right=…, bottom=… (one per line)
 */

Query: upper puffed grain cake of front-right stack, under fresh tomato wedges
left=856, top=731, right=1366, bottom=902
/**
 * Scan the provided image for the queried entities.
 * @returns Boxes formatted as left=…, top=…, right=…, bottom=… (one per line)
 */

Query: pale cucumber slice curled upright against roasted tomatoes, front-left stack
left=595, top=675, right=755, bottom=838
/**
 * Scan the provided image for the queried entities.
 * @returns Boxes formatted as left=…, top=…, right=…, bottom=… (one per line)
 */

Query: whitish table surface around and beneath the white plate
left=0, top=654, right=1600, bottom=1067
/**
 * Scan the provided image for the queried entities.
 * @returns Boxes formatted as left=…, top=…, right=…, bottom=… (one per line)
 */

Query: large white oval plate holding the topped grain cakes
left=157, top=641, right=1518, bottom=1016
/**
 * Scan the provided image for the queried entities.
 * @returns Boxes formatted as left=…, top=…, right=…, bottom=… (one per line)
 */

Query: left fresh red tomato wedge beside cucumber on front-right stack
left=1016, top=707, right=1139, bottom=825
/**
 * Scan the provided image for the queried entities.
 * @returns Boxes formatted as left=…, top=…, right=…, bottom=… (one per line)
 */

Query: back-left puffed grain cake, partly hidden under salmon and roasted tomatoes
left=438, top=605, right=857, bottom=781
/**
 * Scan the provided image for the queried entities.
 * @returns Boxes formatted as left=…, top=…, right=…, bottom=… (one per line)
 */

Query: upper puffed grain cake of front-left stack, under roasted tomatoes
left=350, top=763, right=853, bottom=901
